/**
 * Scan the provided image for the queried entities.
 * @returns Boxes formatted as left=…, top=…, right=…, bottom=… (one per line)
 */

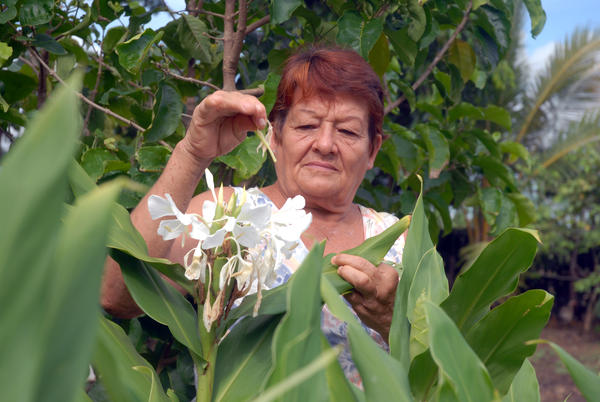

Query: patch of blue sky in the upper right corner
left=525, top=0, right=600, bottom=69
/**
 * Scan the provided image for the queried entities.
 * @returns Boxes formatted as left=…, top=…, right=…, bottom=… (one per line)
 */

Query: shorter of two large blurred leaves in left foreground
left=37, top=181, right=121, bottom=401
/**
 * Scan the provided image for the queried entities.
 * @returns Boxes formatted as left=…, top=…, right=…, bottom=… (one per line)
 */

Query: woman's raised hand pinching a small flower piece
left=182, top=91, right=267, bottom=163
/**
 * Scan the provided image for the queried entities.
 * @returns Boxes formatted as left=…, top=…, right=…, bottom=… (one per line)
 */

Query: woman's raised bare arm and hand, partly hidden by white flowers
left=101, top=91, right=266, bottom=318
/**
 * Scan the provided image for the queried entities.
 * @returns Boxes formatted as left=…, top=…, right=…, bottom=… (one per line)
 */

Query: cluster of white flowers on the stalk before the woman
left=148, top=169, right=312, bottom=331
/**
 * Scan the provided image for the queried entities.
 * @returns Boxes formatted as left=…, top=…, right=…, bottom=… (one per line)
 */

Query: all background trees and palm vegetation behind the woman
left=0, top=0, right=600, bottom=395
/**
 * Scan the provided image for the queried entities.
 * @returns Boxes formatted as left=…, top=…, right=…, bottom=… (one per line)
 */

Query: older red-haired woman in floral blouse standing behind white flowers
left=102, top=47, right=403, bottom=383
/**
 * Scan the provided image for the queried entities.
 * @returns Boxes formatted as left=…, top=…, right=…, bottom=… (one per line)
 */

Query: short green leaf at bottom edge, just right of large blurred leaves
left=92, top=317, right=168, bottom=402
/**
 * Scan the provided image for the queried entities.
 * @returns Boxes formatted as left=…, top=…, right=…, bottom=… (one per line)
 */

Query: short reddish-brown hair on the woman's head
left=269, top=46, right=383, bottom=143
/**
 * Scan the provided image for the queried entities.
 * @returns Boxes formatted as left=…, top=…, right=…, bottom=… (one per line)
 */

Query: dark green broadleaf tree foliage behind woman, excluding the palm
left=0, top=0, right=545, bottom=237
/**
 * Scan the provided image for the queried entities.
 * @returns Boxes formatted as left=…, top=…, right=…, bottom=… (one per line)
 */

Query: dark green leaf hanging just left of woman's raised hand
left=144, top=81, right=183, bottom=142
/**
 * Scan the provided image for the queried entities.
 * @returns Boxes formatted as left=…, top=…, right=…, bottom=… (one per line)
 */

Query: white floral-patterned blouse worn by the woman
left=235, top=187, right=406, bottom=388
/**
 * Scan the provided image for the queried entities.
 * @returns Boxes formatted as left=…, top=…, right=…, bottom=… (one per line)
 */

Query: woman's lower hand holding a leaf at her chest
left=331, top=254, right=398, bottom=342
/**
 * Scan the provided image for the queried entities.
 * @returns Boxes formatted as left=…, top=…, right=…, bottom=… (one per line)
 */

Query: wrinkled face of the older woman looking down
left=273, top=93, right=381, bottom=205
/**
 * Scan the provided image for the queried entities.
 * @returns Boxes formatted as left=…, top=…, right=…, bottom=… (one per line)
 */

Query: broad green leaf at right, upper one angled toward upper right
left=442, top=229, right=538, bottom=333
